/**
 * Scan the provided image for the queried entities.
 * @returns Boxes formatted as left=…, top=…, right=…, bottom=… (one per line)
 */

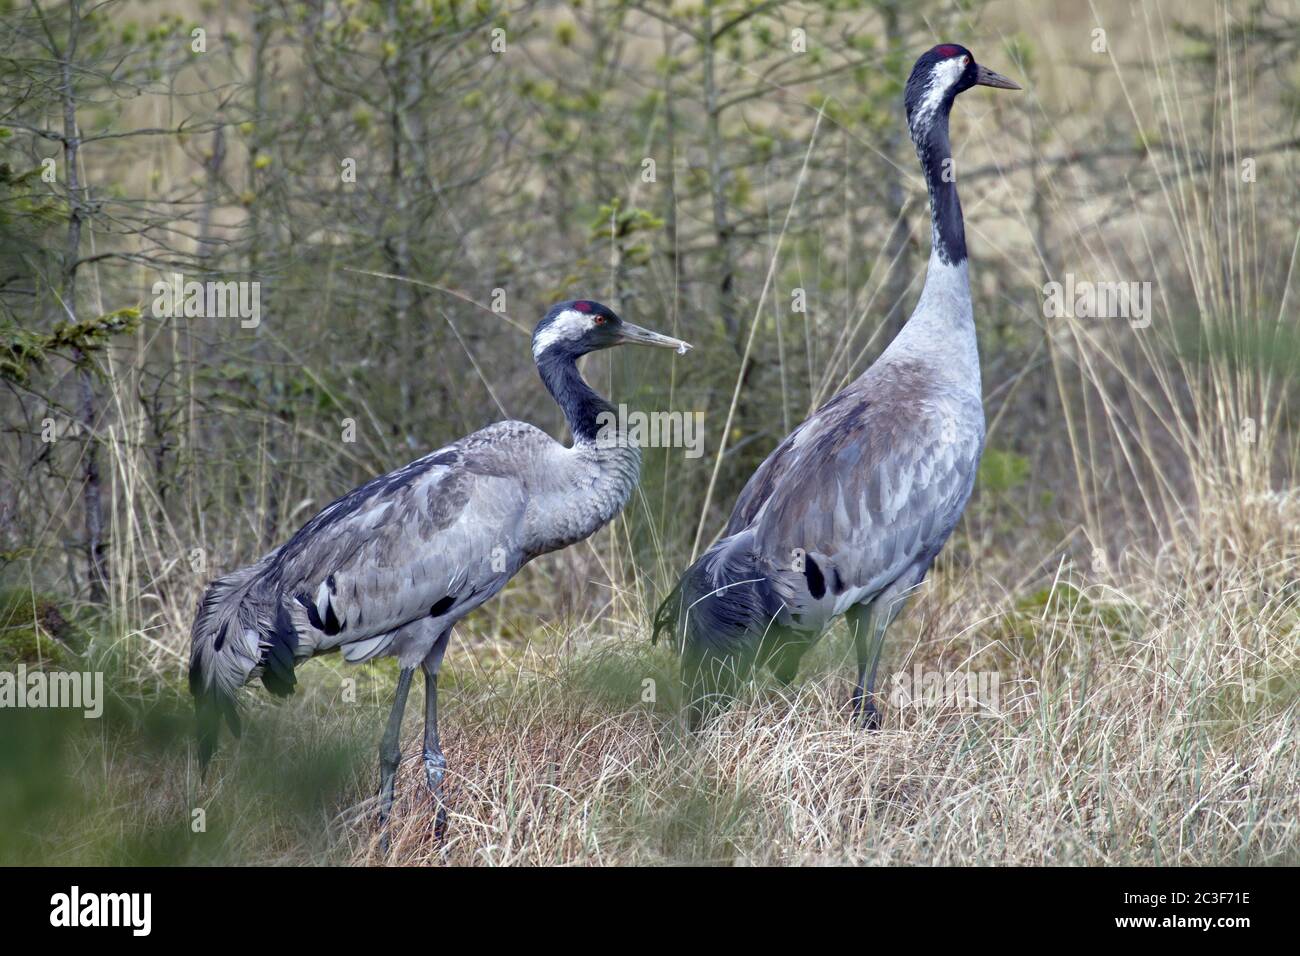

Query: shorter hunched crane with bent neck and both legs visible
left=190, top=300, right=690, bottom=840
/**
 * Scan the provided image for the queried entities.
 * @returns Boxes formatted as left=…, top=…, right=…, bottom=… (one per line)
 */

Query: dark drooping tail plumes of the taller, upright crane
left=651, top=532, right=780, bottom=730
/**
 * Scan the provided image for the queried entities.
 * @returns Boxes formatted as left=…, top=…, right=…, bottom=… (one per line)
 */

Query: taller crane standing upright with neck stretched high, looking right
left=654, top=43, right=1021, bottom=728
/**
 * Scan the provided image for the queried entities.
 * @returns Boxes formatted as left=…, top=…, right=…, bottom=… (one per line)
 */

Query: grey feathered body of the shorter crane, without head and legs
left=189, top=421, right=641, bottom=689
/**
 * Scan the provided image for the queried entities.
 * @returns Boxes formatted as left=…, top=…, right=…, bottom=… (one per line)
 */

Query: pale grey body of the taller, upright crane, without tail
left=724, top=256, right=984, bottom=632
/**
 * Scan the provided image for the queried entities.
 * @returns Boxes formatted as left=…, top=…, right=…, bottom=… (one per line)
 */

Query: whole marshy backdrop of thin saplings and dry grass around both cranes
left=0, top=0, right=1300, bottom=862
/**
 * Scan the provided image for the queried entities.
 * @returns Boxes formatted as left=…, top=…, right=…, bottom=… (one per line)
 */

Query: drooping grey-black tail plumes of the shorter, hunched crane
left=190, top=557, right=298, bottom=767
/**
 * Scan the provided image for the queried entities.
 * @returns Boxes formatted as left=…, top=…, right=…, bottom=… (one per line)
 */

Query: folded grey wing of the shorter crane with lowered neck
left=266, top=423, right=554, bottom=661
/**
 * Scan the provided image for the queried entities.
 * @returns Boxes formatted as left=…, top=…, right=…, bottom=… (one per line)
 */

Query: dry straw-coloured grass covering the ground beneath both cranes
left=5, top=499, right=1300, bottom=865
